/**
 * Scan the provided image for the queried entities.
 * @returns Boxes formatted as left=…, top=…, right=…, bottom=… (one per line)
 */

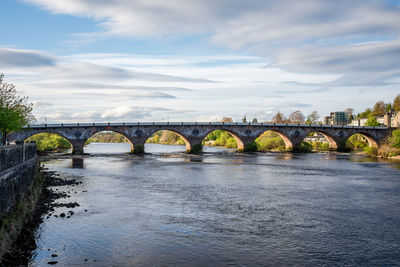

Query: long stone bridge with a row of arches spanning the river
left=7, top=122, right=392, bottom=154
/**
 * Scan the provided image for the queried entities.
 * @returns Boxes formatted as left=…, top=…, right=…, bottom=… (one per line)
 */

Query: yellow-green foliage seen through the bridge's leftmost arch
left=27, top=133, right=71, bottom=151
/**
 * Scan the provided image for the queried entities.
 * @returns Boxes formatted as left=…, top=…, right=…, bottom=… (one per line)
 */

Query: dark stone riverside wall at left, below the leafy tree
left=0, top=144, right=38, bottom=222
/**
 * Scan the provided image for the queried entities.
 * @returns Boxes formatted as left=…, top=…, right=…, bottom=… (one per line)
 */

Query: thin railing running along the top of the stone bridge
left=24, top=122, right=388, bottom=129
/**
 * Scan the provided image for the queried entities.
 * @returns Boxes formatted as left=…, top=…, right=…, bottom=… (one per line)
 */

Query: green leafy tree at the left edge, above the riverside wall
left=0, top=74, right=34, bottom=145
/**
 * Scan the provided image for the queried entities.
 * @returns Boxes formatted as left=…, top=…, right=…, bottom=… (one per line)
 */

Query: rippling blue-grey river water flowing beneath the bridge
left=31, top=143, right=400, bottom=266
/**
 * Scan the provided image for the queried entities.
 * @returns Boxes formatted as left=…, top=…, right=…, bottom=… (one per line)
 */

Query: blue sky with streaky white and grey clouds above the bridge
left=0, top=0, right=400, bottom=123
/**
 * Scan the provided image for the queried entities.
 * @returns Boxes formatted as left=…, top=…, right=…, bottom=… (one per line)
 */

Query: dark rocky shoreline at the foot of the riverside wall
left=0, top=164, right=82, bottom=266
